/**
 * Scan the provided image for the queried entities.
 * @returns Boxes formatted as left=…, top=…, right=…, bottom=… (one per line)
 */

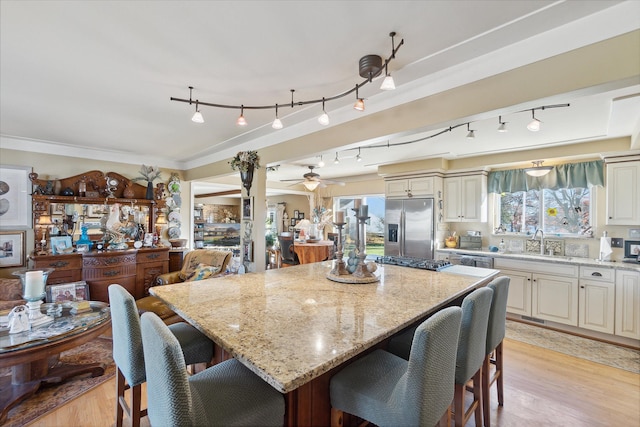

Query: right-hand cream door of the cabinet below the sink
left=531, top=274, right=578, bottom=326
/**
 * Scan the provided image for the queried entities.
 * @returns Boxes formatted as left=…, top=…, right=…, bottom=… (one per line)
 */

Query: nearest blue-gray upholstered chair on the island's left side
left=141, top=312, right=284, bottom=427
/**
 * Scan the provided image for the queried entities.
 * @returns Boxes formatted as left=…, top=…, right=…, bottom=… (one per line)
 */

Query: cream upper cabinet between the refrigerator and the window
left=444, top=172, right=487, bottom=222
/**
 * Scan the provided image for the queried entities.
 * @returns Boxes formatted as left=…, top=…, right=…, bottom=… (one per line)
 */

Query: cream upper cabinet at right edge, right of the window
left=607, top=160, right=640, bottom=226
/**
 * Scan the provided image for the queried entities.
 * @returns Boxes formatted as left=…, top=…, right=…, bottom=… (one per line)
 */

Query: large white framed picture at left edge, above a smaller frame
left=0, top=165, right=32, bottom=229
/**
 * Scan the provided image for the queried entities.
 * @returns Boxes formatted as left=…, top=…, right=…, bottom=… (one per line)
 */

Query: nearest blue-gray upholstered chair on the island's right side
left=330, top=307, right=462, bottom=426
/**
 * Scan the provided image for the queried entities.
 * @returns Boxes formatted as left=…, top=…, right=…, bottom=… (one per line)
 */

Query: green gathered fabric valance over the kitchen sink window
left=488, top=160, right=604, bottom=194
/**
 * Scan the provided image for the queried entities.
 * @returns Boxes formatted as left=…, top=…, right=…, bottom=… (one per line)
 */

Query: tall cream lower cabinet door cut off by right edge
left=615, top=270, right=640, bottom=339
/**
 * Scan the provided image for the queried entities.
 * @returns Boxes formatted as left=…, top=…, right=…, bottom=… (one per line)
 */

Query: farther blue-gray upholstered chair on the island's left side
left=109, top=284, right=213, bottom=427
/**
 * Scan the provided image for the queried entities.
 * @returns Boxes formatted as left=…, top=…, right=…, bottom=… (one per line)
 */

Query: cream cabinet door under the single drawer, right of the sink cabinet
left=578, top=279, right=615, bottom=334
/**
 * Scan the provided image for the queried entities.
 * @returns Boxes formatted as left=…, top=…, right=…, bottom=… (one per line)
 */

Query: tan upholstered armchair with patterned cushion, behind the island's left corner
left=136, top=249, right=231, bottom=325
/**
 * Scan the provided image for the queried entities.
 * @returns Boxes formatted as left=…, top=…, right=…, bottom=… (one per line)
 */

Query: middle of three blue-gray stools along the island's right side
left=453, top=287, right=493, bottom=427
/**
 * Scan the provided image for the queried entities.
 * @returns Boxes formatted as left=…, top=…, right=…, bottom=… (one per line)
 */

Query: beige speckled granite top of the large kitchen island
left=150, top=261, right=498, bottom=393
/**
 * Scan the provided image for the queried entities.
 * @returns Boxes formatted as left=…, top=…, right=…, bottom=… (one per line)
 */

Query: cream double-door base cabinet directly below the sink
left=494, top=258, right=578, bottom=326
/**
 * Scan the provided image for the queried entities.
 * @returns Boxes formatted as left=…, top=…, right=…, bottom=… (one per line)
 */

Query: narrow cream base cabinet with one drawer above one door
left=578, top=266, right=616, bottom=334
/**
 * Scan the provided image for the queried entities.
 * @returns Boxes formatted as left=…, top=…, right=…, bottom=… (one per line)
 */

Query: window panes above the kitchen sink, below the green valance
left=497, top=188, right=591, bottom=236
